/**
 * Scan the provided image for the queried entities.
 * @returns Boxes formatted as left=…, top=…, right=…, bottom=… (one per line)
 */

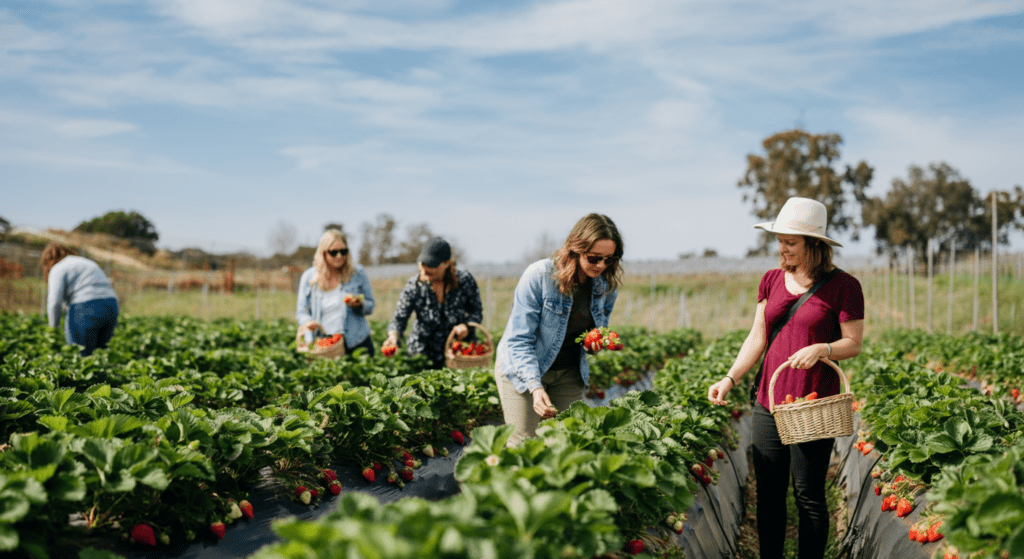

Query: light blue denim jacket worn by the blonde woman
left=295, top=264, right=374, bottom=347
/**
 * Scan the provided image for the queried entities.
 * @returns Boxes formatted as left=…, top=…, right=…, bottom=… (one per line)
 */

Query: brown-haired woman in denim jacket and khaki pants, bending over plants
left=495, top=214, right=623, bottom=446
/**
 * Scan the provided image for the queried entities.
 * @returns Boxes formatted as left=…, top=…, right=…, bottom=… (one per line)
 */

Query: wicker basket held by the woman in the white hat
left=768, top=359, right=853, bottom=444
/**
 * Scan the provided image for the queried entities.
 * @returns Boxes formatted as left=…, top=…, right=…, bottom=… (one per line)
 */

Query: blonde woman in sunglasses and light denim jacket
left=295, top=229, right=374, bottom=355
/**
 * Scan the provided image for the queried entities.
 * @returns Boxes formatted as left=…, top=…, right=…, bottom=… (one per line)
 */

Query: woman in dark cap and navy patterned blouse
left=381, top=238, right=483, bottom=368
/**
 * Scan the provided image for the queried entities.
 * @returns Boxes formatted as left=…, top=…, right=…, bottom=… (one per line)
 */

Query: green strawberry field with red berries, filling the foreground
left=6, top=313, right=1024, bottom=559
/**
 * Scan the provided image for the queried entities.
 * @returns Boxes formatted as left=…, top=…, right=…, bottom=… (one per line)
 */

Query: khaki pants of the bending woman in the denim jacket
left=495, top=364, right=585, bottom=446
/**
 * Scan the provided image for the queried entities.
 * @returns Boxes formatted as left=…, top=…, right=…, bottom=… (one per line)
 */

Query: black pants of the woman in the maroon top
left=752, top=402, right=835, bottom=559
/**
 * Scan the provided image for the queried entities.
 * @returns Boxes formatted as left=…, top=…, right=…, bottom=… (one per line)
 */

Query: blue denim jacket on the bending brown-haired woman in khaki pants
left=497, top=258, right=617, bottom=393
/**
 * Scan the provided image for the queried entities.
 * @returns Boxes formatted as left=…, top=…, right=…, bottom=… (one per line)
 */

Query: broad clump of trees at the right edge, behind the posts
left=863, top=162, right=1024, bottom=259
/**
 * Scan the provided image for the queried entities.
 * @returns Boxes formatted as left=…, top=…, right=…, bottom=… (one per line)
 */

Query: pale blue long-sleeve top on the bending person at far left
left=46, top=255, right=118, bottom=328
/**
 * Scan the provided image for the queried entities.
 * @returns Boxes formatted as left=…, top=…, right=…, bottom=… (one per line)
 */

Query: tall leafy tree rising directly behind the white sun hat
left=737, top=128, right=874, bottom=255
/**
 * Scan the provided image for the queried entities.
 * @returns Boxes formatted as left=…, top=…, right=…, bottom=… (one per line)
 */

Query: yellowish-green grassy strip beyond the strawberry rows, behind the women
left=8, top=270, right=1024, bottom=338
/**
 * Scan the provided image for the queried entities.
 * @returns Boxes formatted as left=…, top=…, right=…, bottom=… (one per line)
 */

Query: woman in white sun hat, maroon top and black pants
left=708, top=198, right=864, bottom=559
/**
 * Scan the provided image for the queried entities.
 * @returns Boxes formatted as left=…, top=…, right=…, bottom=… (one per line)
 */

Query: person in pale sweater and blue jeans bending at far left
left=39, top=243, right=119, bottom=356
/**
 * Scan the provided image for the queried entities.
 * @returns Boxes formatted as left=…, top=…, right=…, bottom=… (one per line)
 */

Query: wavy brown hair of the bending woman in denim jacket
left=552, top=214, right=623, bottom=295
